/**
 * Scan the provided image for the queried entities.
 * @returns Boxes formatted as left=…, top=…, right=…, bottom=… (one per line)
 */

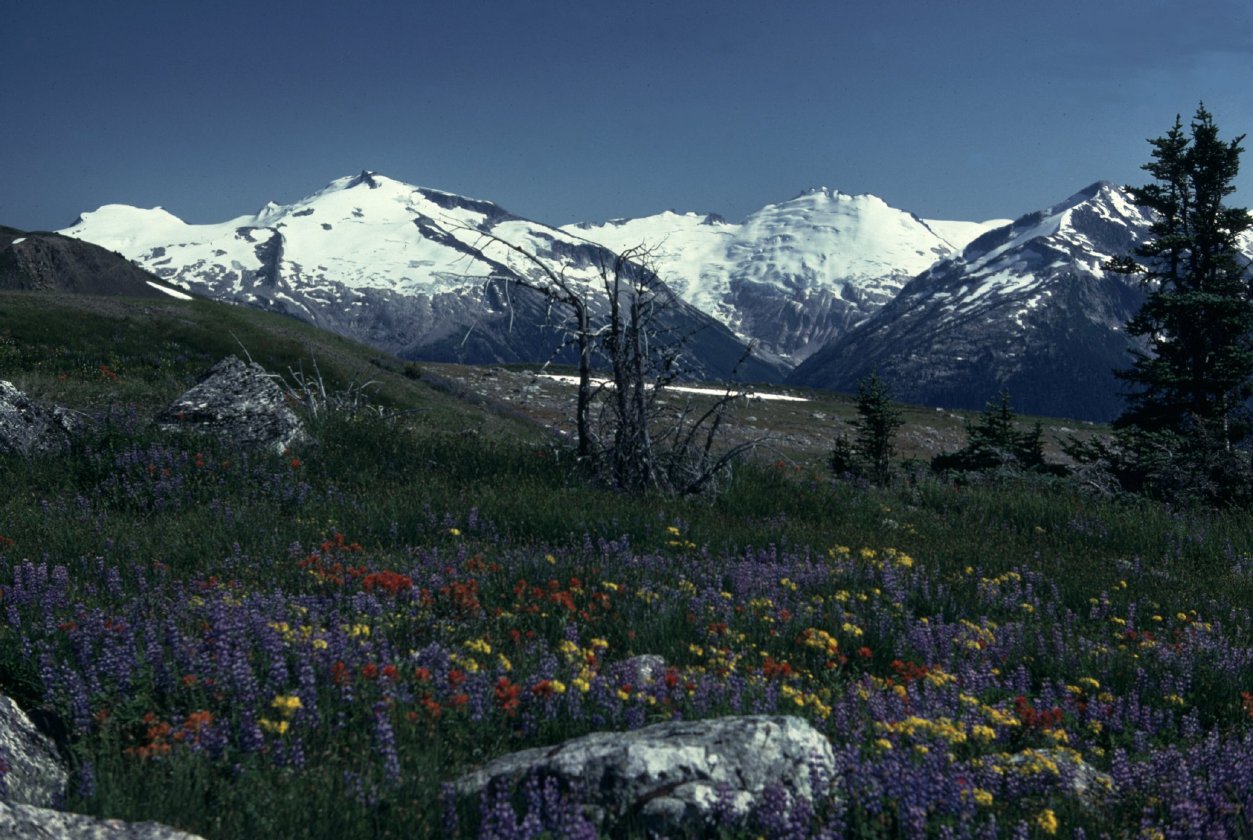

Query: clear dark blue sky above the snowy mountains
left=0, top=0, right=1253, bottom=228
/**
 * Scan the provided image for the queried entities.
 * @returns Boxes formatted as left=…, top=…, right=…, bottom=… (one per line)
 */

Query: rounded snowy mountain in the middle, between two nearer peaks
left=563, top=187, right=1007, bottom=364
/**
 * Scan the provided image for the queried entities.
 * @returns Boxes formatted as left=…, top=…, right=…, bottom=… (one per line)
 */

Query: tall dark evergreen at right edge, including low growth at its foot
left=1102, top=105, right=1253, bottom=504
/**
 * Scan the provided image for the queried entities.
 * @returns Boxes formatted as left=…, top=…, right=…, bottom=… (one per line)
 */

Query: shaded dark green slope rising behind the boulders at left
left=0, top=291, right=539, bottom=439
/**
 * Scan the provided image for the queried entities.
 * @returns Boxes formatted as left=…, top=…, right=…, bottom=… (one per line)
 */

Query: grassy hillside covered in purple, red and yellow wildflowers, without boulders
left=0, top=295, right=1253, bottom=839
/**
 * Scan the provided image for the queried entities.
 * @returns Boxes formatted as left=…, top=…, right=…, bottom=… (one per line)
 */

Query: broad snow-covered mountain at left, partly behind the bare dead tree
left=63, top=172, right=782, bottom=380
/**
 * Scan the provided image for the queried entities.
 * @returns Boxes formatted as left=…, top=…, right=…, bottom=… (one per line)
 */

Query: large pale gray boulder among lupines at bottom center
left=455, top=715, right=836, bottom=834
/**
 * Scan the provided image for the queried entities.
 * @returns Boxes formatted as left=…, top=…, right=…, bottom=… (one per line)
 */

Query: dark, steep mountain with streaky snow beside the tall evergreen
left=788, top=182, right=1149, bottom=420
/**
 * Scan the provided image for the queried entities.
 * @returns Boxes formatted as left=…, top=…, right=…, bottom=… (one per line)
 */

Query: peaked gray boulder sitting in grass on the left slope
left=157, top=356, right=308, bottom=454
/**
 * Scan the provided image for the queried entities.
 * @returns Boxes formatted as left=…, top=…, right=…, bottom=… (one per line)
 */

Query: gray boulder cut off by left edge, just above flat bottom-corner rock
left=0, top=695, right=69, bottom=812
